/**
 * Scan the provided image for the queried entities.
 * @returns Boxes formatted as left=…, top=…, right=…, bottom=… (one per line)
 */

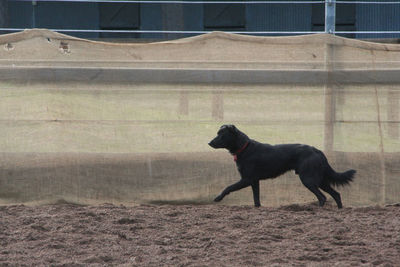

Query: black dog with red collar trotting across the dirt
left=209, top=125, right=356, bottom=209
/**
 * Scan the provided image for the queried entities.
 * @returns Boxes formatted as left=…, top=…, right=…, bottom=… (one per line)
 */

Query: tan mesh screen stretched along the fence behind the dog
left=0, top=30, right=400, bottom=206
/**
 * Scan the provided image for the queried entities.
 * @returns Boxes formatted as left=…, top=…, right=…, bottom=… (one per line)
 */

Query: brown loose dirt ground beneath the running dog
left=0, top=203, right=400, bottom=266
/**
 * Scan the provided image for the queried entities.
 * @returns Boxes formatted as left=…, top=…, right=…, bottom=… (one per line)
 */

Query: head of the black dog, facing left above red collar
left=208, top=125, right=240, bottom=151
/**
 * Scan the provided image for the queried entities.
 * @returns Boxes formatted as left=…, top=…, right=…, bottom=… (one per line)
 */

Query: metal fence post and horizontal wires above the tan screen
left=0, top=0, right=400, bottom=35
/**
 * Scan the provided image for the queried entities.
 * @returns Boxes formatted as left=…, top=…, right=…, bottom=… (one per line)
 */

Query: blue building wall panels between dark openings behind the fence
left=8, top=1, right=400, bottom=38
